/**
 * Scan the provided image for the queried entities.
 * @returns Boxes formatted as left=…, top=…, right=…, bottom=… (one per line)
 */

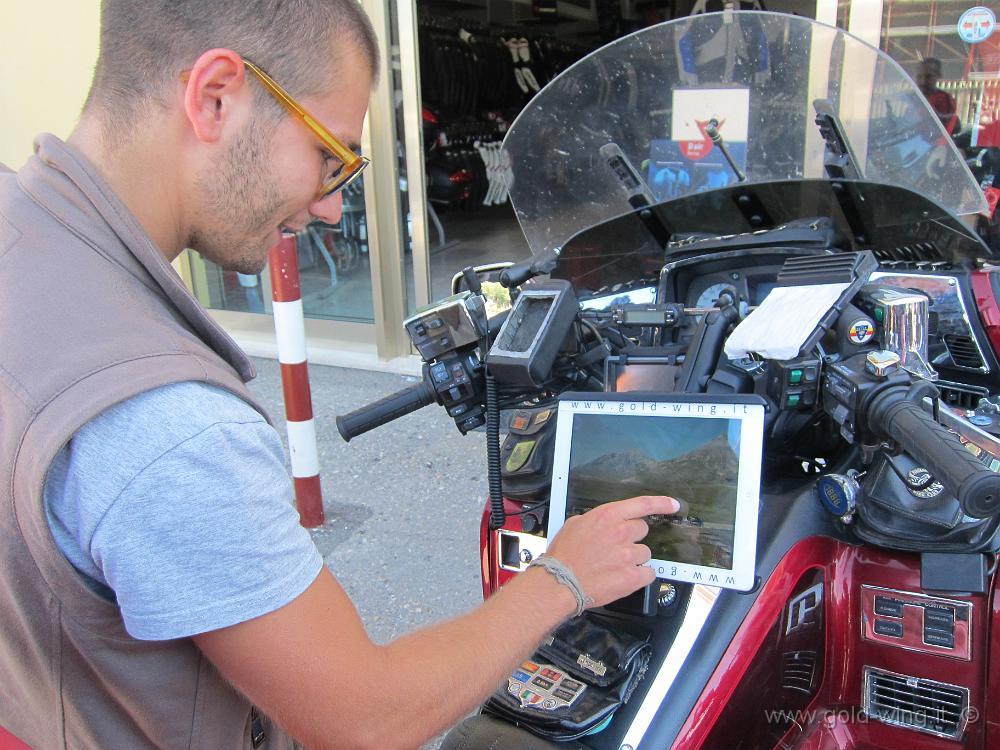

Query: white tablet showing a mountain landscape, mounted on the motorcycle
left=548, top=393, right=764, bottom=591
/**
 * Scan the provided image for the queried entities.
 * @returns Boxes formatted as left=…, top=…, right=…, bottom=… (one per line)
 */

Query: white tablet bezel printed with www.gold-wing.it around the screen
left=547, top=393, right=764, bottom=591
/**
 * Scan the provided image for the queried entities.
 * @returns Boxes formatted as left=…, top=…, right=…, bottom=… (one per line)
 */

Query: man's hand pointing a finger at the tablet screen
left=548, top=495, right=680, bottom=607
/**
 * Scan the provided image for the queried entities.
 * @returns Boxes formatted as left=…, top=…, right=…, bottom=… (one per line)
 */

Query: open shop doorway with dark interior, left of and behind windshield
left=399, top=0, right=840, bottom=310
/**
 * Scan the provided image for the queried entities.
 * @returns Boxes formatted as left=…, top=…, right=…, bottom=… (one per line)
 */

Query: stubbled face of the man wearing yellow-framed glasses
left=190, top=50, right=372, bottom=274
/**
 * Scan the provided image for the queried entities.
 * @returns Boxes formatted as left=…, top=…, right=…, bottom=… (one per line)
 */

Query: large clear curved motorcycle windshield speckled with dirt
left=504, top=12, right=986, bottom=254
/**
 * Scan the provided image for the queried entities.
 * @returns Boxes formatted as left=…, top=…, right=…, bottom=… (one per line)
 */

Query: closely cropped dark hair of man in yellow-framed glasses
left=84, top=0, right=379, bottom=134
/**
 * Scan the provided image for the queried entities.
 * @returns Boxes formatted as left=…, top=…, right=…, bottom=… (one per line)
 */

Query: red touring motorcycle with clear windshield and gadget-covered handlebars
left=337, top=12, right=1000, bottom=750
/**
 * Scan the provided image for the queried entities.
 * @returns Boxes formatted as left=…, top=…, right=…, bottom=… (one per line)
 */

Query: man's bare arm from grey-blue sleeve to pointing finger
left=194, top=497, right=677, bottom=750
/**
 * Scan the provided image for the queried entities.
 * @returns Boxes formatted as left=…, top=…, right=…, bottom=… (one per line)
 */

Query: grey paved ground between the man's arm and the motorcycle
left=251, top=359, right=487, bottom=748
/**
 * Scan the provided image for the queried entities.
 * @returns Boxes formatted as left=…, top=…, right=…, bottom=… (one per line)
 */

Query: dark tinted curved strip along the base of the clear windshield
left=552, top=180, right=989, bottom=297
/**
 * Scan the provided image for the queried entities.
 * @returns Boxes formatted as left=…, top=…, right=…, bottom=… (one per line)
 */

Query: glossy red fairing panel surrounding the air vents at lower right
left=672, top=537, right=996, bottom=750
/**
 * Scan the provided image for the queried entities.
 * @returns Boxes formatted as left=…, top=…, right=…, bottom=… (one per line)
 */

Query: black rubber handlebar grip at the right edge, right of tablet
left=868, top=389, right=1000, bottom=518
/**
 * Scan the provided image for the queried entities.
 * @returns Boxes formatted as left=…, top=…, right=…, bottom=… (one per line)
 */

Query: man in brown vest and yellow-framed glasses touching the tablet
left=0, top=0, right=676, bottom=750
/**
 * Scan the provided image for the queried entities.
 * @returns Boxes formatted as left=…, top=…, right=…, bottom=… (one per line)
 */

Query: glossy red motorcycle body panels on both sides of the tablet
left=480, top=500, right=1000, bottom=750
